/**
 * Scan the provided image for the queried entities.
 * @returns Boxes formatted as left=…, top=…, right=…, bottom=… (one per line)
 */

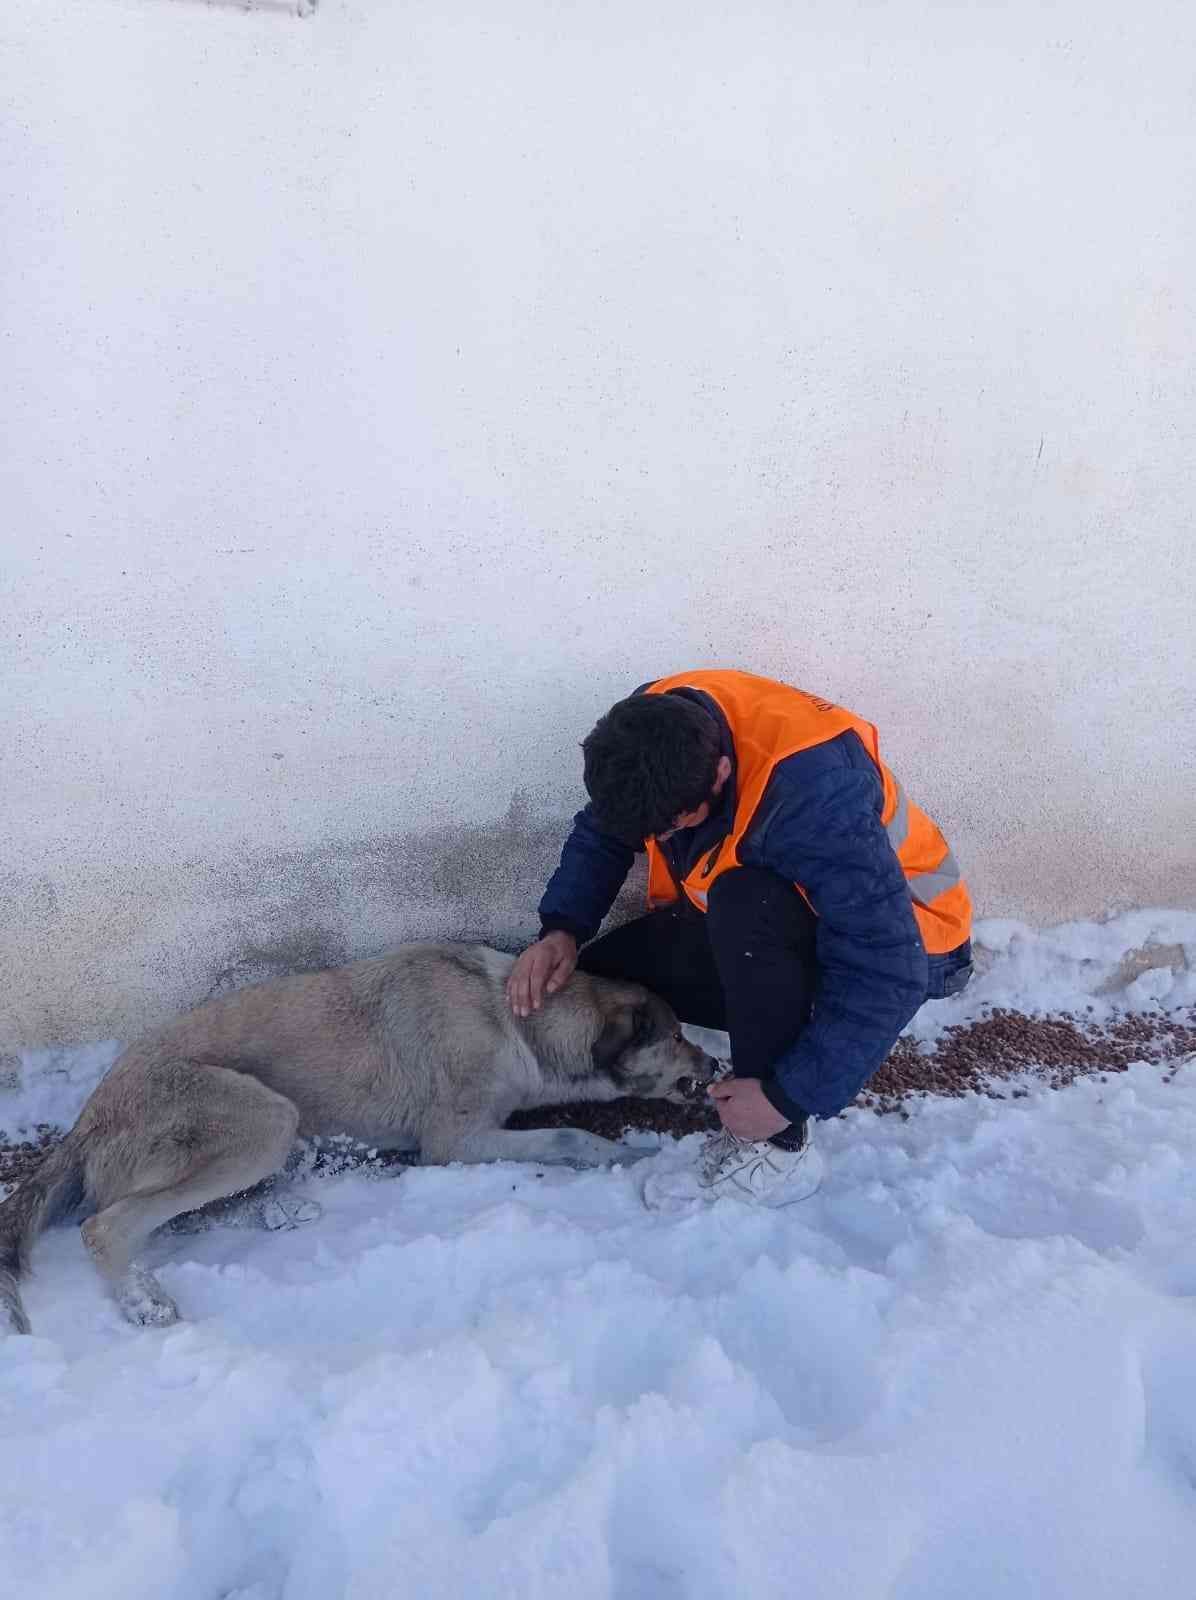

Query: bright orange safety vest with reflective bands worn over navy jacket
left=643, top=672, right=972, bottom=955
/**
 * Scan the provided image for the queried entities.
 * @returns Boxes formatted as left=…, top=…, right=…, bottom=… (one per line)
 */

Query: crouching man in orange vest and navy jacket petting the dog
left=507, top=670, right=972, bottom=1205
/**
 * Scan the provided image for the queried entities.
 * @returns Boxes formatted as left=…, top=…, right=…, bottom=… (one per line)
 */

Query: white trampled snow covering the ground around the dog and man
left=0, top=914, right=1196, bottom=1600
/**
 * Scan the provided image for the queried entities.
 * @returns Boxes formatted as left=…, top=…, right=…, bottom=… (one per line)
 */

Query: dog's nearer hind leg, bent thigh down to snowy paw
left=82, top=1062, right=299, bottom=1326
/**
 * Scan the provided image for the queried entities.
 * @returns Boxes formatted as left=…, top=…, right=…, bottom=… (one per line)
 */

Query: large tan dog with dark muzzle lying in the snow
left=0, top=944, right=718, bottom=1333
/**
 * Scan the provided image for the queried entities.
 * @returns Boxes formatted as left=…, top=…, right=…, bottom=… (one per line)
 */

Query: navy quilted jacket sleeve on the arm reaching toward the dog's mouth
left=740, top=734, right=927, bottom=1118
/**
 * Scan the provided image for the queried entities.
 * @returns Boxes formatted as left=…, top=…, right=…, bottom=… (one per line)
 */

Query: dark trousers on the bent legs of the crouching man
left=577, top=867, right=817, bottom=1139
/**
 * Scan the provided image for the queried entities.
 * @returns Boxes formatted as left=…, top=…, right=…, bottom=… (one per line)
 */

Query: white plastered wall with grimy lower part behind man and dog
left=0, top=0, right=1196, bottom=1046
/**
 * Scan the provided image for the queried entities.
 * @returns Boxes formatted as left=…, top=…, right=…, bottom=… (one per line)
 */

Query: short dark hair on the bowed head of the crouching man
left=582, top=694, right=721, bottom=845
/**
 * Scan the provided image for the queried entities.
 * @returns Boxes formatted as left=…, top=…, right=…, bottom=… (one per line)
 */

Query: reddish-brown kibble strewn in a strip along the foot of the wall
left=0, top=1006, right=1196, bottom=1187
